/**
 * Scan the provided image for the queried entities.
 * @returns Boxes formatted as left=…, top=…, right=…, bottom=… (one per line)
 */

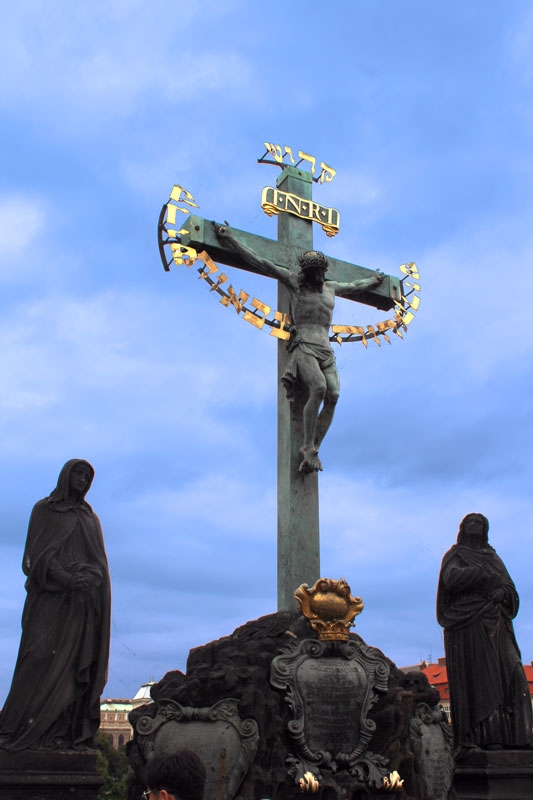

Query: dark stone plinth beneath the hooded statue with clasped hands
left=0, top=750, right=103, bottom=800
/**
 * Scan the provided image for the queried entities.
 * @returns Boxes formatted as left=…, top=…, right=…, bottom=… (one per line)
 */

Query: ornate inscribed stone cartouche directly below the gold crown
left=270, top=639, right=389, bottom=788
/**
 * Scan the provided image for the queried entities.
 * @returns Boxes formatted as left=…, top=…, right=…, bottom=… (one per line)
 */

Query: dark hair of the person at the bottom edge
left=143, top=749, right=205, bottom=800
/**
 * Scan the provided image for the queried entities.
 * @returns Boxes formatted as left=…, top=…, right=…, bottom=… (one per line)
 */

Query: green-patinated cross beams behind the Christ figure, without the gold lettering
left=172, top=167, right=401, bottom=611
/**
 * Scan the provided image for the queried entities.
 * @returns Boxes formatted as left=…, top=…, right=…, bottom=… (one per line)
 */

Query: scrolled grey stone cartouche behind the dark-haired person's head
left=134, top=697, right=259, bottom=800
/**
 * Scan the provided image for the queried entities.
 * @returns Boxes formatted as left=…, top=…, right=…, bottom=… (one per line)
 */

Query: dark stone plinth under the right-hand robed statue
left=453, top=750, right=533, bottom=800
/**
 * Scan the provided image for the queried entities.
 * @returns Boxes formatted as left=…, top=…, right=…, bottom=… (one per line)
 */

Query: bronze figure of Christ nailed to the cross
left=215, top=225, right=385, bottom=472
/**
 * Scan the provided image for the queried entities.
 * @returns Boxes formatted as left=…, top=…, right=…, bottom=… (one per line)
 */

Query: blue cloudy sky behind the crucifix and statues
left=0, top=0, right=533, bottom=703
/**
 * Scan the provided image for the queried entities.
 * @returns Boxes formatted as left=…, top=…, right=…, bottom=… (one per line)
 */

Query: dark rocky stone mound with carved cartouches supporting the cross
left=127, top=611, right=452, bottom=800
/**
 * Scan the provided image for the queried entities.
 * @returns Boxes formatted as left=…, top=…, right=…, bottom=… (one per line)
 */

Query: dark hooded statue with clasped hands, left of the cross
left=0, top=459, right=111, bottom=752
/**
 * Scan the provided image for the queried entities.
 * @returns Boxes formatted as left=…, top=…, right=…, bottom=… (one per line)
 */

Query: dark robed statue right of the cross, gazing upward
left=437, top=514, right=533, bottom=756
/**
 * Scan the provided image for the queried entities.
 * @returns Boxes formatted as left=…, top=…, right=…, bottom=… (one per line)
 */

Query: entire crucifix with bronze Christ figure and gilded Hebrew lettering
left=159, top=146, right=420, bottom=611
